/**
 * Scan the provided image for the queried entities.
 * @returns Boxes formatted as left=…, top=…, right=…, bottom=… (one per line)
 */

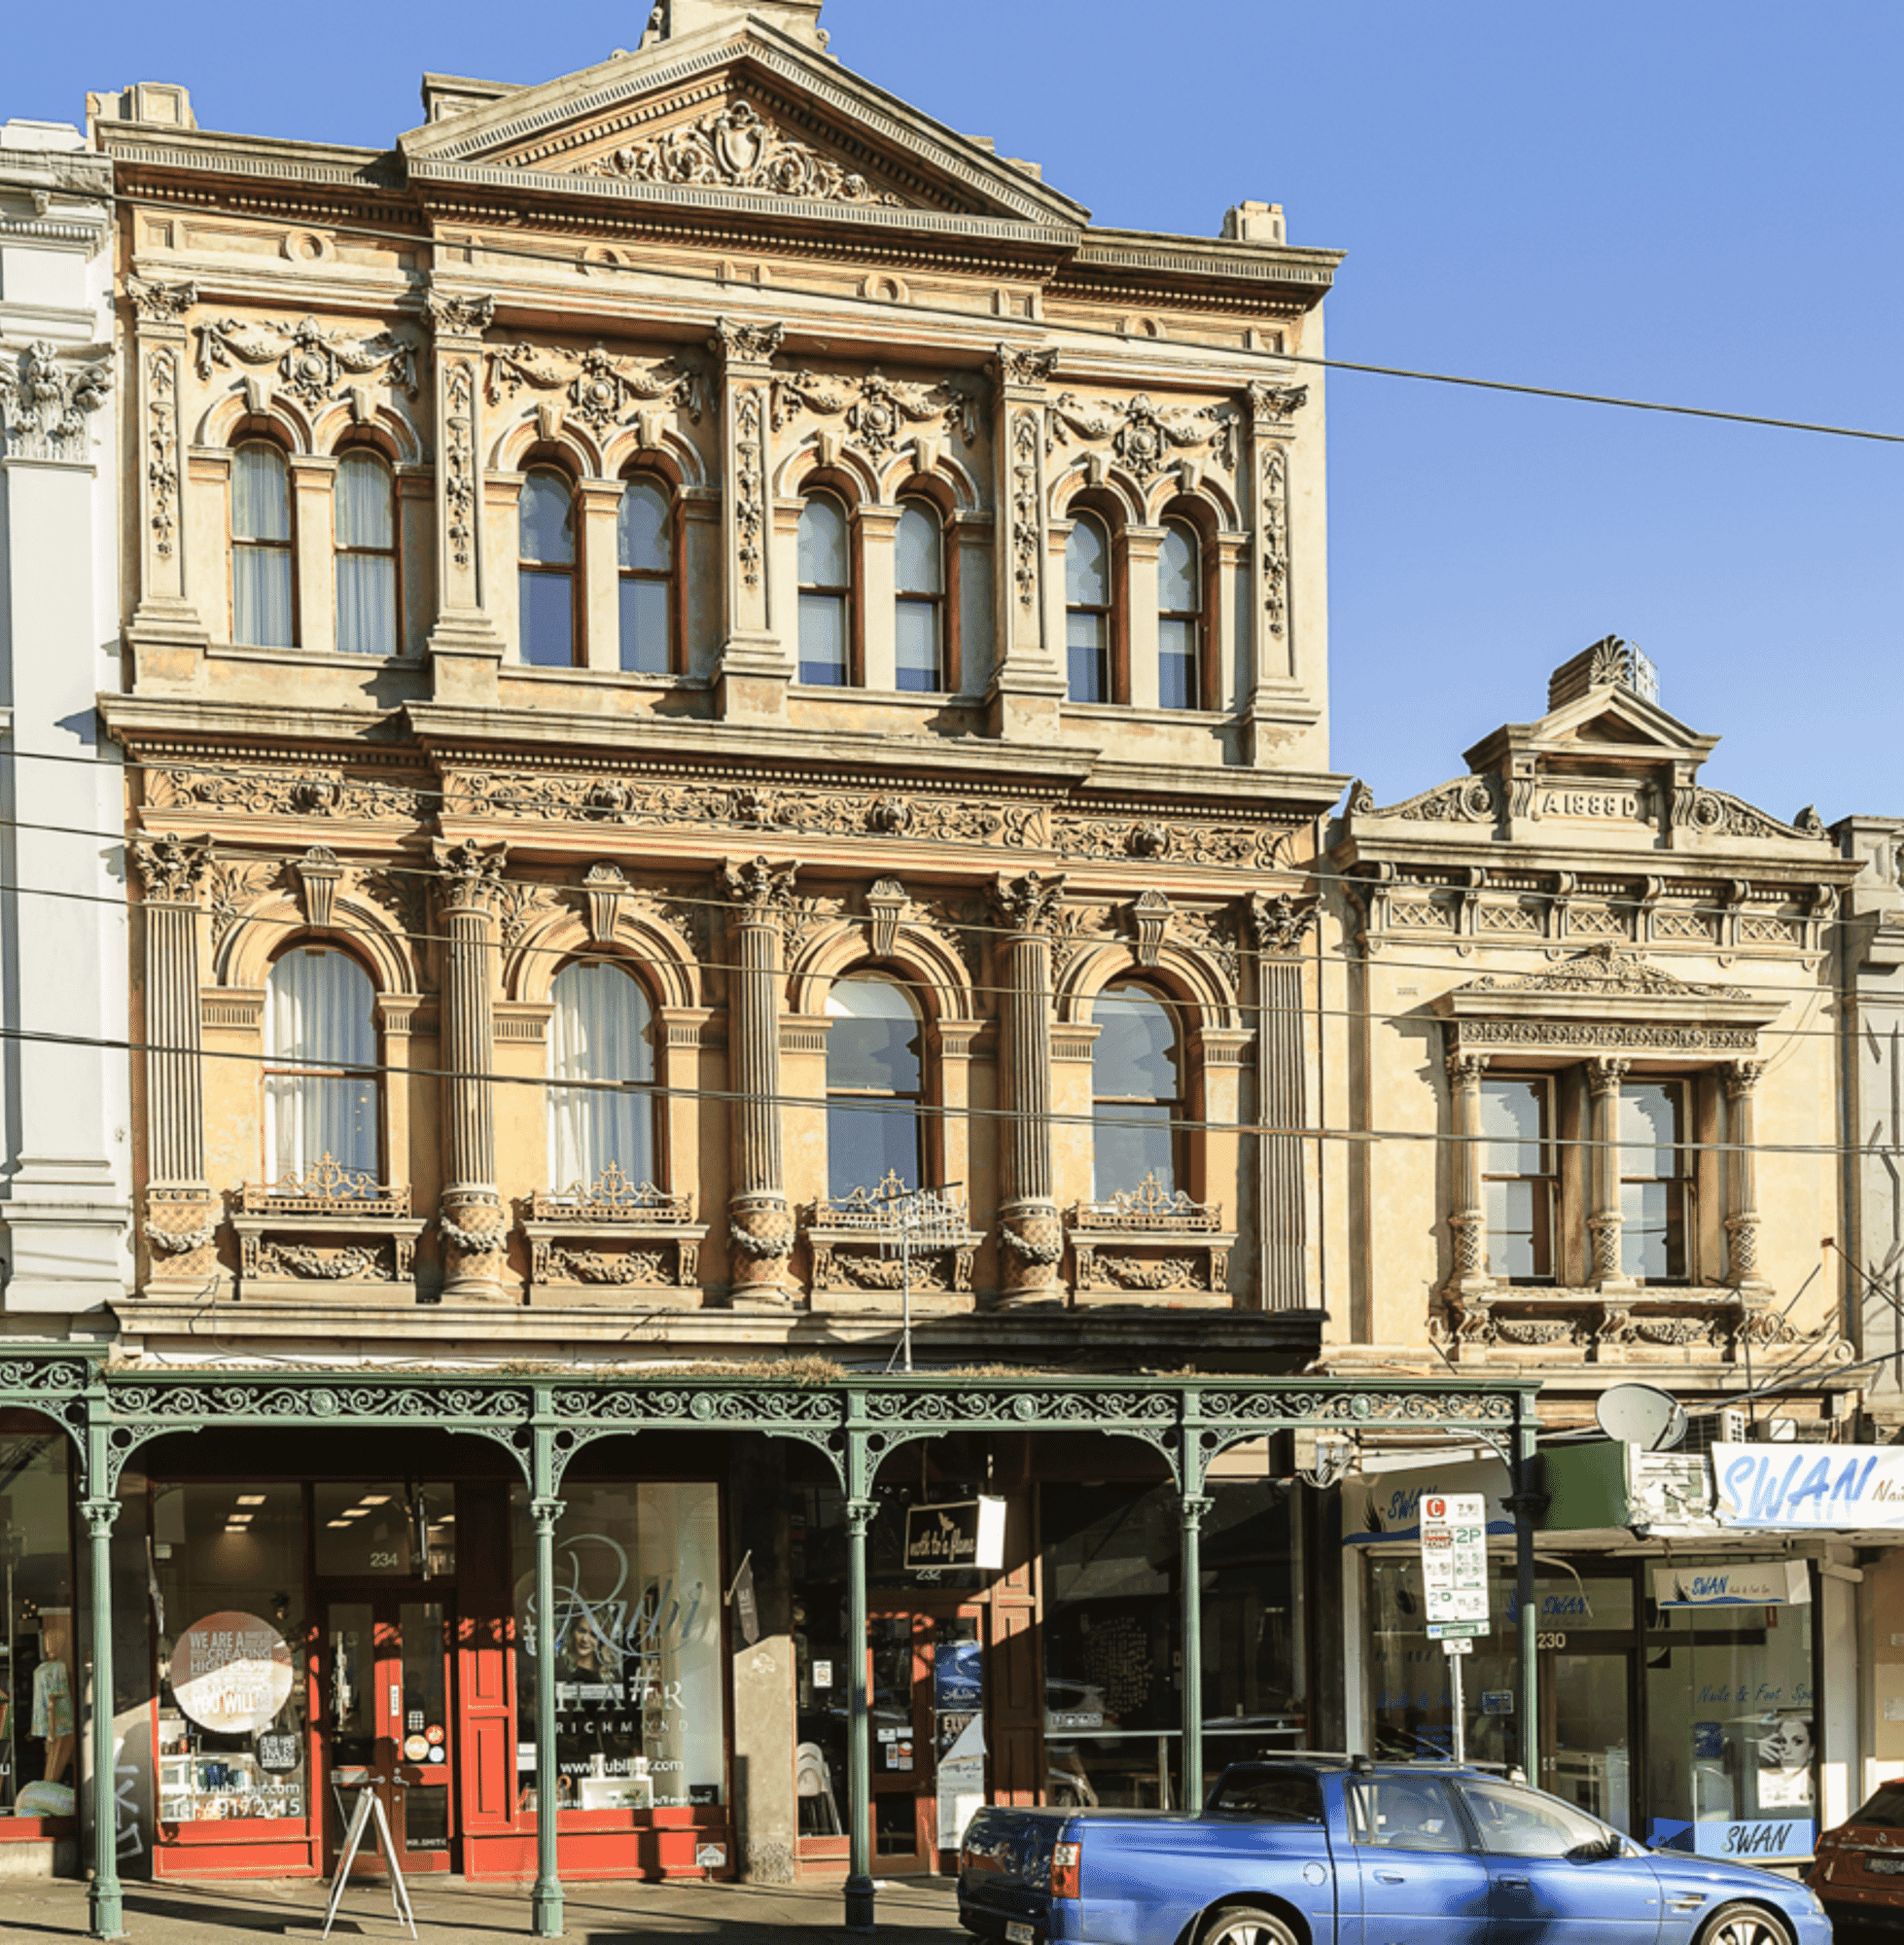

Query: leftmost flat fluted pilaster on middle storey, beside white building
left=128, top=836, right=218, bottom=1286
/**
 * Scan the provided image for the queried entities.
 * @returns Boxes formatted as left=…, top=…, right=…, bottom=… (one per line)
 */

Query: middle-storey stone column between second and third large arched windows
left=722, top=858, right=797, bottom=1303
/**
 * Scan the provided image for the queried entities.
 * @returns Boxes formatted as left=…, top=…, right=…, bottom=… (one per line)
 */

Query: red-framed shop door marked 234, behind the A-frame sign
left=319, top=1585, right=457, bottom=1875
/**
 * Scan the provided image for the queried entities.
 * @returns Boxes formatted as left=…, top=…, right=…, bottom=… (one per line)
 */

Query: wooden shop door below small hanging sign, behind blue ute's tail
left=867, top=1607, right=986, bottom=1875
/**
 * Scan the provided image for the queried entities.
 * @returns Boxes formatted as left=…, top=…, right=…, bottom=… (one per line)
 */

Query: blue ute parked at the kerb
left=959, top=1756, right=1836, bottom=1945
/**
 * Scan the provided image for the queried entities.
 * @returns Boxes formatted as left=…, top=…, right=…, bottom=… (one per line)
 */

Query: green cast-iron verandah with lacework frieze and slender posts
left=0, top=1346, right=1538, bottom=1939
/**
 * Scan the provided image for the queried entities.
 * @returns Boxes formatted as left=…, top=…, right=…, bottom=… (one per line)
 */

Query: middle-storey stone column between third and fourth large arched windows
left=994, top=871, right=1064, bottom=1303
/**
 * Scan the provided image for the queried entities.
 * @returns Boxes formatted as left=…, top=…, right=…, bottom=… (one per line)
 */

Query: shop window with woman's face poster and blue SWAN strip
left=1645, top=1558, right=1818, bottom=1863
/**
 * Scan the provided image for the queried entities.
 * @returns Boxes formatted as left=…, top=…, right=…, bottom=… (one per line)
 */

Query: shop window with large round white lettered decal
left=152, top=1482, right=309, bottom=1822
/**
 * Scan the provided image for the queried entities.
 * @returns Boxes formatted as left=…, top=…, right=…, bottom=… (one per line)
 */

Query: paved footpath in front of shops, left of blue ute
left=0, top=1877, right=961, bottom=1945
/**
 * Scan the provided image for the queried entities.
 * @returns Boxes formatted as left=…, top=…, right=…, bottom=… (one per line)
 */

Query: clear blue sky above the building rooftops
left=11, top=0, right=1904, bottom=819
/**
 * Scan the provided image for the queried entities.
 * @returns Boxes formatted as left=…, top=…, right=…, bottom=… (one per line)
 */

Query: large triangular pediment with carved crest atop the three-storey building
left=399, top=16, right=1089, bottom=230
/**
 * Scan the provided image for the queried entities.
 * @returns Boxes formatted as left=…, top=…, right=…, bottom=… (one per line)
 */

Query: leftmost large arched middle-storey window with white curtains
left=264, top=945, right=377, bottom=1183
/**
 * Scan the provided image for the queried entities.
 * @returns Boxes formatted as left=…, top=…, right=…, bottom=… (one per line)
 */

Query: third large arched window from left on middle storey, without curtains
left=827, top=972, right=924, bottom=1198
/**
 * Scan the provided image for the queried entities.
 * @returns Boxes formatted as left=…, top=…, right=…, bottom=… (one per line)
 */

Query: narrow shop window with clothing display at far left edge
left=0, top=1432, right=80, bottom=1817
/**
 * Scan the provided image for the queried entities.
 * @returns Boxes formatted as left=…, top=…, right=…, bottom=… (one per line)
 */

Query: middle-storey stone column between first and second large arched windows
left=436, top=838, right=510, bottom=1303
